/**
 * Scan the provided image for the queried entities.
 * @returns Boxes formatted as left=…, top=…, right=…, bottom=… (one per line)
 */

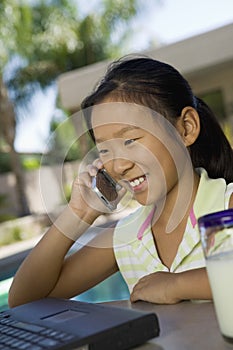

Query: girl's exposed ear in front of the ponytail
left=176, top=107, right=200, bottom=147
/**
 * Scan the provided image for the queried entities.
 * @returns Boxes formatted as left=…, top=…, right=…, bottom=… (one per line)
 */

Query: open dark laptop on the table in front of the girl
left=0, top=298, right=159, bottom=350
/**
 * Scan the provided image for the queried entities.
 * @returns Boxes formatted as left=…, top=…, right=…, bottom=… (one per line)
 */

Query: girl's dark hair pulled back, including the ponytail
left=81, top=57, right=233, bottom=183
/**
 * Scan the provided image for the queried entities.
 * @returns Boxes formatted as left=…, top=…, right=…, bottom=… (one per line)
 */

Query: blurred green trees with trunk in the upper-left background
left=0, top=0, right=139, bottom=215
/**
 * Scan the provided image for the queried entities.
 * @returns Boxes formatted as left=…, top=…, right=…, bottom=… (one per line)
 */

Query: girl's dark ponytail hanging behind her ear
left=190, top=97, right=233, bottom=183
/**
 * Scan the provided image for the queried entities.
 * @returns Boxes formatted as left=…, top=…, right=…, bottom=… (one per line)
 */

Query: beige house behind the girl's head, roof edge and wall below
left=58, top=23, right=233, bottom=129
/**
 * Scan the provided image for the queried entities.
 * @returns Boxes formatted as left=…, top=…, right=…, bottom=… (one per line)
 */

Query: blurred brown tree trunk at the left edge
left=0, top=76, right=30, bottom=216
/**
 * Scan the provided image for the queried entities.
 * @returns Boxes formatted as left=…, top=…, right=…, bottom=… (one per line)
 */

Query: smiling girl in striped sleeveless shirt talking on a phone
left=9, top=57, right=233, bottom=307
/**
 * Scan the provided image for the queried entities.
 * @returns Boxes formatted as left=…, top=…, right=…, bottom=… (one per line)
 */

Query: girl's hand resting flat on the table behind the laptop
left=130, top=272, right=181, bottom=304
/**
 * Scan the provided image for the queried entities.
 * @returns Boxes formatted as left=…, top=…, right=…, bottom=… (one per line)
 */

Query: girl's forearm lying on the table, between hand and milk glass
left=173, top=268, right=212, bottom=300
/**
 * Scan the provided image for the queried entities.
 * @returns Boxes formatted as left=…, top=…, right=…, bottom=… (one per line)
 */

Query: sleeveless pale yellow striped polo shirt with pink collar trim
left=113, top=168, right=233, bottom=292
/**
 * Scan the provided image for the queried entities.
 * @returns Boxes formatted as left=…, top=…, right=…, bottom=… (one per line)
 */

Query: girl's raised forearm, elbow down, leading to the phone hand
left=9, top=207, right=96, bottom=307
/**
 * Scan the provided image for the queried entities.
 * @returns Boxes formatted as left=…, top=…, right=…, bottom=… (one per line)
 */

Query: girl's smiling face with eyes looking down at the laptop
left=92, top=102, right=189, bottom=205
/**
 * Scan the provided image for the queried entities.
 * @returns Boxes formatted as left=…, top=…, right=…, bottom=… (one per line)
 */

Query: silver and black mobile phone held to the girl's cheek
left=92, top=169, right=122, bottom=211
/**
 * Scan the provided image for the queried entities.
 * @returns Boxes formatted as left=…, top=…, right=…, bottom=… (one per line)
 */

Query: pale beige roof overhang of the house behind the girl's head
left=58, top=23, right=233, bottom=111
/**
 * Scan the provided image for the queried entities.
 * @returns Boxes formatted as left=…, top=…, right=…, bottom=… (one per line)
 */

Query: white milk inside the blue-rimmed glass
left=206, top=252, right=233, bottom=338
